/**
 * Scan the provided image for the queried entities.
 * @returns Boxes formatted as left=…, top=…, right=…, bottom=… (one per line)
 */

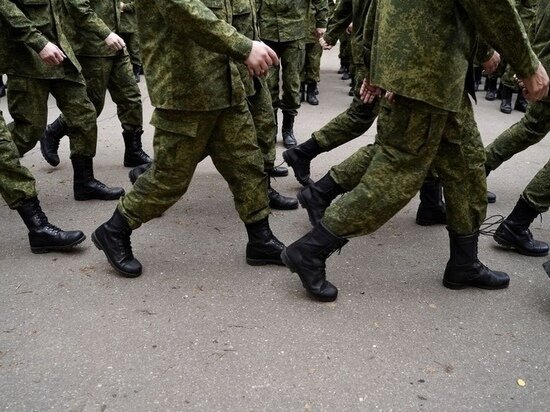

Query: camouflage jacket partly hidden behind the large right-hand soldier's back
left=323, top=0, right=371, bottom=65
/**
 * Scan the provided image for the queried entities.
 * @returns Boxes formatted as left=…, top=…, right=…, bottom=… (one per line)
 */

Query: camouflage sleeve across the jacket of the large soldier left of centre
left=152, top=0, right=252, bottom=61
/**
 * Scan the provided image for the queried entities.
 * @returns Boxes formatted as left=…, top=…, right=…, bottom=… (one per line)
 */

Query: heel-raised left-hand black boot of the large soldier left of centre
left=92, top=209, right=142, bottom=278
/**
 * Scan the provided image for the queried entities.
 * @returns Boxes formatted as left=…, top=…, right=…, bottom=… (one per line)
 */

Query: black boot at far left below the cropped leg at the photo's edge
left=17, top=197, right=86, bottom=253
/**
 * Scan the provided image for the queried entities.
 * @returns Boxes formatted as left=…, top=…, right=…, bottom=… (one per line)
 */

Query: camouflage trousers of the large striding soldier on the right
left=323, top=93, right=487, bottom=237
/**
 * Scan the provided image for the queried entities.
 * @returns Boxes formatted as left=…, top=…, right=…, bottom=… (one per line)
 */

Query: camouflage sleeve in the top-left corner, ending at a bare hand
left=0, top=0, right=49, bottom=53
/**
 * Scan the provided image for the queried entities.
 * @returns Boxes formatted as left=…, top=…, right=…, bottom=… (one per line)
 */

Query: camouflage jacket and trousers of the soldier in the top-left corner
left=0, top=0, right=97, bottom=156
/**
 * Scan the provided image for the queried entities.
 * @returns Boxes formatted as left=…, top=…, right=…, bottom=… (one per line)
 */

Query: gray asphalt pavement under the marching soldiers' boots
left=0, top=50, right=550, bottom=411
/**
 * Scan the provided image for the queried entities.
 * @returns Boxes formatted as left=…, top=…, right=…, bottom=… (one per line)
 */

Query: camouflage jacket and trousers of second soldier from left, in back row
left=58, top=0, right=143, bottom=131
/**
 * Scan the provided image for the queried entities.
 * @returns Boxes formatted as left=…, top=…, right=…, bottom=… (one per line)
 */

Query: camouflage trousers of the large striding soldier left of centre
left=118, top=101, right=269, bottom=229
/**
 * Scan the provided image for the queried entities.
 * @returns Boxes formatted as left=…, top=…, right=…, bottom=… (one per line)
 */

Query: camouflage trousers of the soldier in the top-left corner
left=8, top=73, right=97, bottom=157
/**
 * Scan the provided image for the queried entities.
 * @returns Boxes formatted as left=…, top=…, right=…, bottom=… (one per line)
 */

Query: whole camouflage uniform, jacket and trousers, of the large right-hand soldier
left=323, top=0, right=538, bottom=237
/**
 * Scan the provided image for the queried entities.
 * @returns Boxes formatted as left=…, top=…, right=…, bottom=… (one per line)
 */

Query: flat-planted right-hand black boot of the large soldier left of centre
left=245, top=217, right=285, bottom=266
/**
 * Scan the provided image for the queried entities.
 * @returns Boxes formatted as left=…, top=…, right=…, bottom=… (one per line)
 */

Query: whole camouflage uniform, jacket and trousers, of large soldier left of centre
left=118, top=0, right=269, bottom=228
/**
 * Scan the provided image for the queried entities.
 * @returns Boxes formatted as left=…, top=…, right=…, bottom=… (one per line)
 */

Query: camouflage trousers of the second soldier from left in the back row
left=60, top=54, right=143, bottom=130
